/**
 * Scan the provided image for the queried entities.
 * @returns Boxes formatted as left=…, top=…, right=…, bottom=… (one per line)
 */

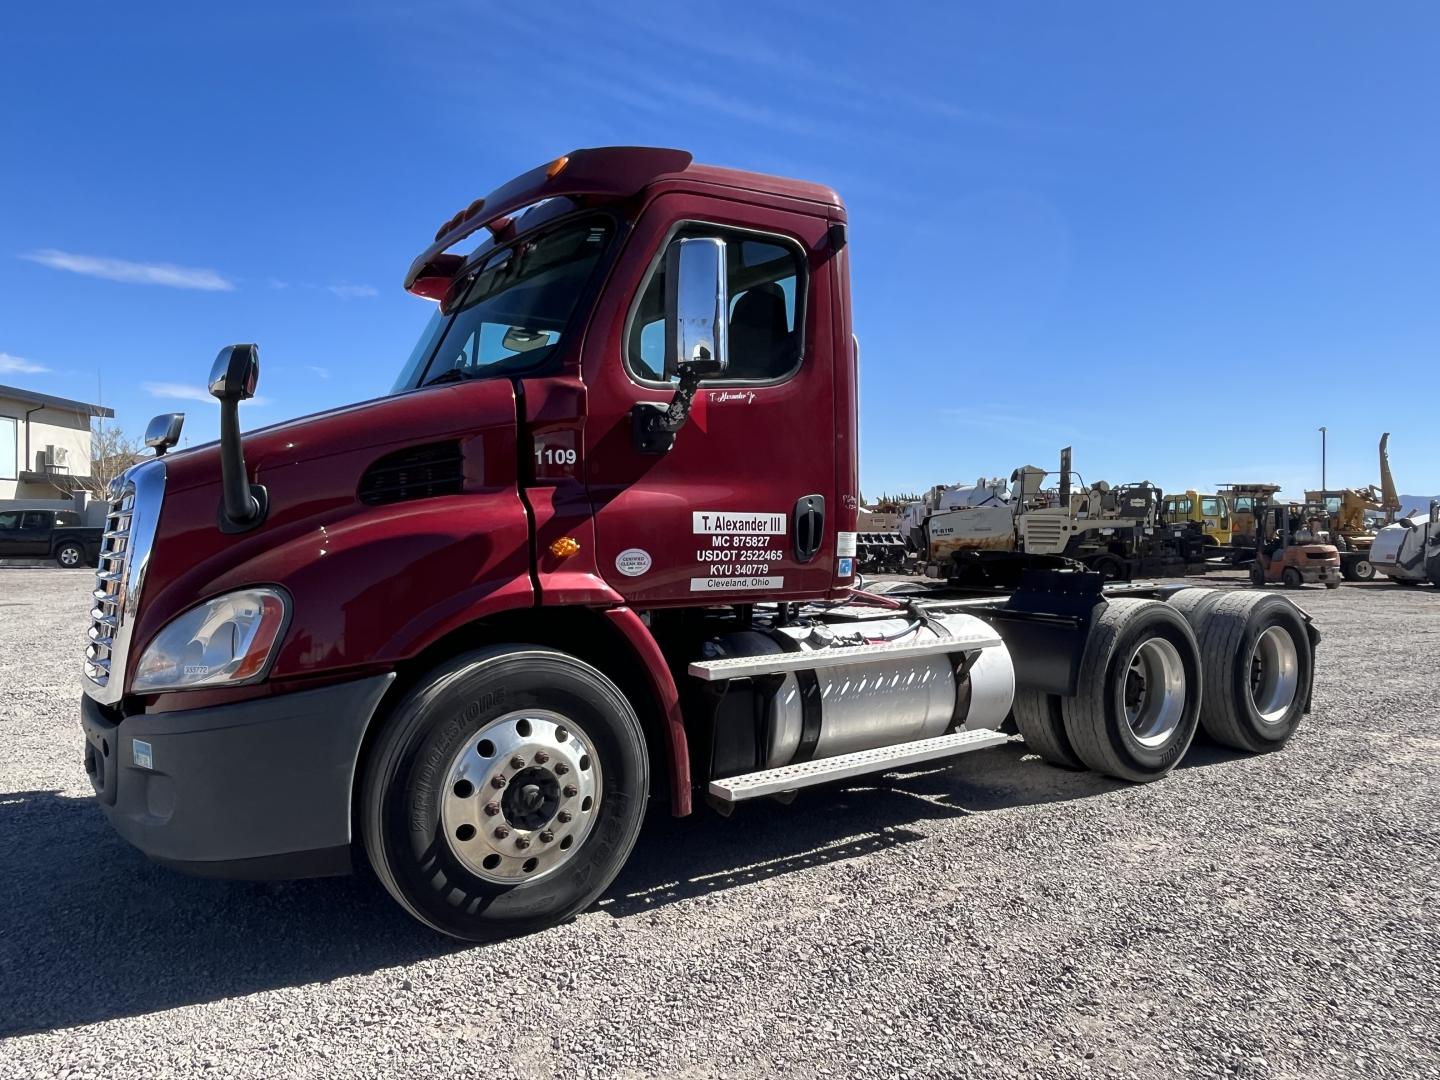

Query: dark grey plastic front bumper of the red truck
left=81, top=675, right=395, bottom=878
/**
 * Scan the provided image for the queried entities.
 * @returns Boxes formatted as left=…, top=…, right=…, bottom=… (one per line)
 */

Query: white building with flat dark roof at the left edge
left=0, top=386, right=115, bottom=507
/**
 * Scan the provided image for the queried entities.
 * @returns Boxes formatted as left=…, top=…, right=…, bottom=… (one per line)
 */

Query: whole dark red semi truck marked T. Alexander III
left=81, top=147, right=1318, bottom=939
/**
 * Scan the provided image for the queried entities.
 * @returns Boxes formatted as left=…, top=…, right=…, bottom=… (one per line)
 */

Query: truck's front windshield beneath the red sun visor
left=393, top=220, right=611, bottom=392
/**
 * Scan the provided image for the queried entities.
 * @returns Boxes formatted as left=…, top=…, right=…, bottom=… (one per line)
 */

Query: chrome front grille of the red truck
left=85, top=461, right=166, bottom=704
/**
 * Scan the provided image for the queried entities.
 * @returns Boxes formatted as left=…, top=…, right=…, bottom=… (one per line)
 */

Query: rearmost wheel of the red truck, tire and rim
left=1200, top=592, right=1315, bottom=753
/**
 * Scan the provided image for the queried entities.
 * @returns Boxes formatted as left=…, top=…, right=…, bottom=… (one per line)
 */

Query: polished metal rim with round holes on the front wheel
left=441, top=708, right=602, bottom=886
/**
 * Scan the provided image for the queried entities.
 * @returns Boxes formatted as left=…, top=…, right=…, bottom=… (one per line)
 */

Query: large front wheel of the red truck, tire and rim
left=359, top=645, right=649, bottom=942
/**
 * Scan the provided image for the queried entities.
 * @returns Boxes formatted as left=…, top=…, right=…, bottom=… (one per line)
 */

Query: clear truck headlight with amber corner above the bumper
left=130, top=589, right=289, bottom=694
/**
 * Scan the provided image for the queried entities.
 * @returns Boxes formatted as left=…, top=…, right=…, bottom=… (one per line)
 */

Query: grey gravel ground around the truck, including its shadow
left=0, top=569, right=1440, bottom=1079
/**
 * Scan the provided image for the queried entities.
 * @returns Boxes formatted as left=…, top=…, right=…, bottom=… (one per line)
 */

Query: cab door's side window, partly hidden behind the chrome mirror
left=625, top=225, right=805, bottom=383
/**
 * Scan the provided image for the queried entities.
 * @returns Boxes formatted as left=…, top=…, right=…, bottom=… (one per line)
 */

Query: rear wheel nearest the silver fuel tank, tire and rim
left=1061, top=599, right=1201, bottom=783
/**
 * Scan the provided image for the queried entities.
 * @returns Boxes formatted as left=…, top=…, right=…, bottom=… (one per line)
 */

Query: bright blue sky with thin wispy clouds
left=0, top=0, right=1440, bottom=495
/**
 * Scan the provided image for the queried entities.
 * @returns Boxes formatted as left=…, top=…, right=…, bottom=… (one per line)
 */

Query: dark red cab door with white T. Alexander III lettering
left=583, top=193, right=854, bottom=605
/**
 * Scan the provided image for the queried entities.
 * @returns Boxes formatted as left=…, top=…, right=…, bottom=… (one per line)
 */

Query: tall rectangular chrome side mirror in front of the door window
left=665, top=236, right=730, bottom=382
